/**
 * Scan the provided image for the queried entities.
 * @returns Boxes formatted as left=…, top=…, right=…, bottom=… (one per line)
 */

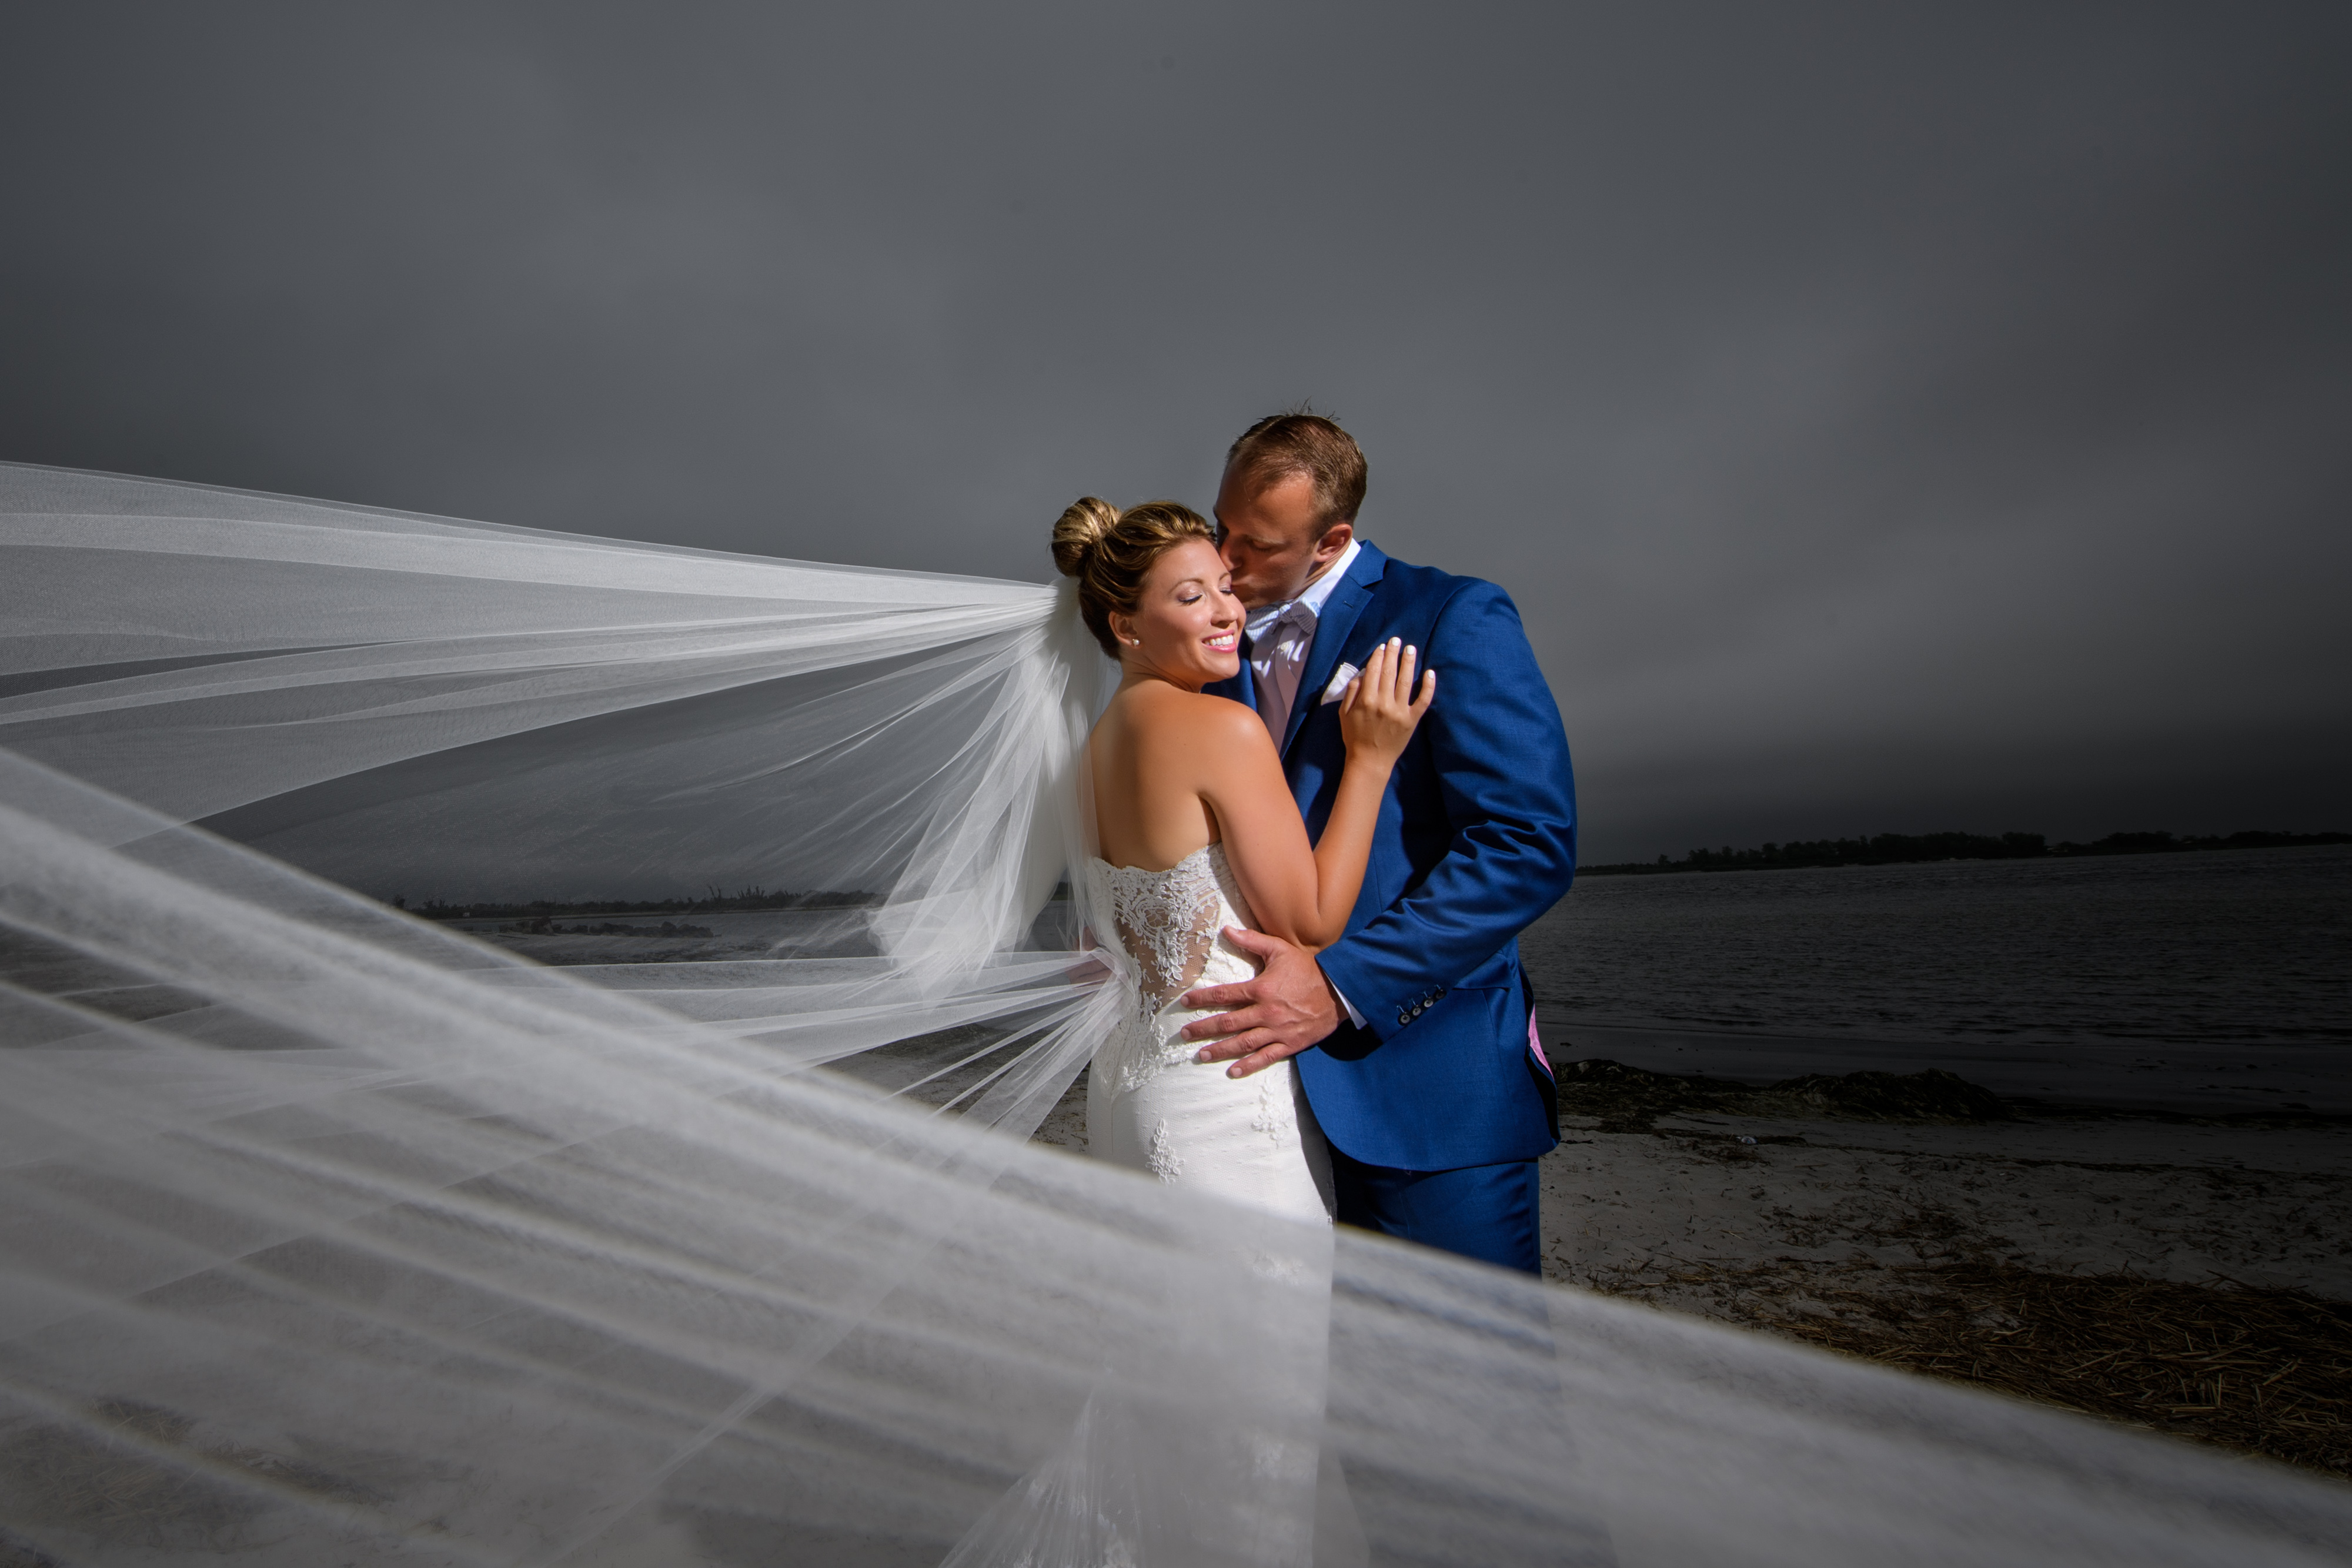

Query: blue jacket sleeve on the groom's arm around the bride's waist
left=1319, top=581, right=1576, bottom=1041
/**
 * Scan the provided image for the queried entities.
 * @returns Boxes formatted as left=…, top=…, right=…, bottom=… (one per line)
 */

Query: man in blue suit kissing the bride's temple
left=1185, top=414, right=1576, bottom=1274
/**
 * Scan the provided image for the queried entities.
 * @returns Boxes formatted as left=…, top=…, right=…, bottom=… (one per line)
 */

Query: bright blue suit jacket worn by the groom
left=1209, top=546, right=1576, bottom=1171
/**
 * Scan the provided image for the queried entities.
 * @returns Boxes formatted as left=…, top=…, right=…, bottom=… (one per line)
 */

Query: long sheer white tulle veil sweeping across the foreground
left=0, top=466, right=2352, bottom=1568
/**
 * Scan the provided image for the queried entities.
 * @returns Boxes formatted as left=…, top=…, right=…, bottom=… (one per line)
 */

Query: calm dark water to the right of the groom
left=1522, top=846, right=2352, bottom=1109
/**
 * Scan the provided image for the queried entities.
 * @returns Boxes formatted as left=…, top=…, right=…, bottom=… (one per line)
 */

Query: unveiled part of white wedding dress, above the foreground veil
left=1087, top=844, right=1331, bottom=1222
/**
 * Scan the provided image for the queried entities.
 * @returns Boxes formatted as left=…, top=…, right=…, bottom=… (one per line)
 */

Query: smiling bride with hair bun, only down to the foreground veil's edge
left=1054, top=496, right=1437, bottom=1220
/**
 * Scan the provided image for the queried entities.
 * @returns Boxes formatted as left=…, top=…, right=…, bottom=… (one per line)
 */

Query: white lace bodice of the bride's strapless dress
left=1087, top=844, right=1256, bottom=1079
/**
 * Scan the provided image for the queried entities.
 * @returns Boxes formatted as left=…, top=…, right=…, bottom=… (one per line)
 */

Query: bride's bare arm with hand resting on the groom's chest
left=1200, top=642, right=1437, bottom=947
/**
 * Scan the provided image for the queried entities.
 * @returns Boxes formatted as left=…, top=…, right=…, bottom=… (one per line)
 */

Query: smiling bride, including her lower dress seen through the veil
left=927, top=496, right=1437, bottom=1568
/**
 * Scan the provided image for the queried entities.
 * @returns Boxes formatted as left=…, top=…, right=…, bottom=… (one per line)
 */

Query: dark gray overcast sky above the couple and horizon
left=0, top=0, right=2352, bottom=860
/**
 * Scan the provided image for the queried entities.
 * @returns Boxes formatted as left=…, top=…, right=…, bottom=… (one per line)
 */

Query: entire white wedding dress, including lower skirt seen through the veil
left=941, top=844, right=1369, bottom=1568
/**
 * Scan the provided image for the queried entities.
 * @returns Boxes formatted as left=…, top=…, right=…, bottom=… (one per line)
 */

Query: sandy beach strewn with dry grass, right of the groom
left=1545, top=1060, right=2352, bottom=1476
